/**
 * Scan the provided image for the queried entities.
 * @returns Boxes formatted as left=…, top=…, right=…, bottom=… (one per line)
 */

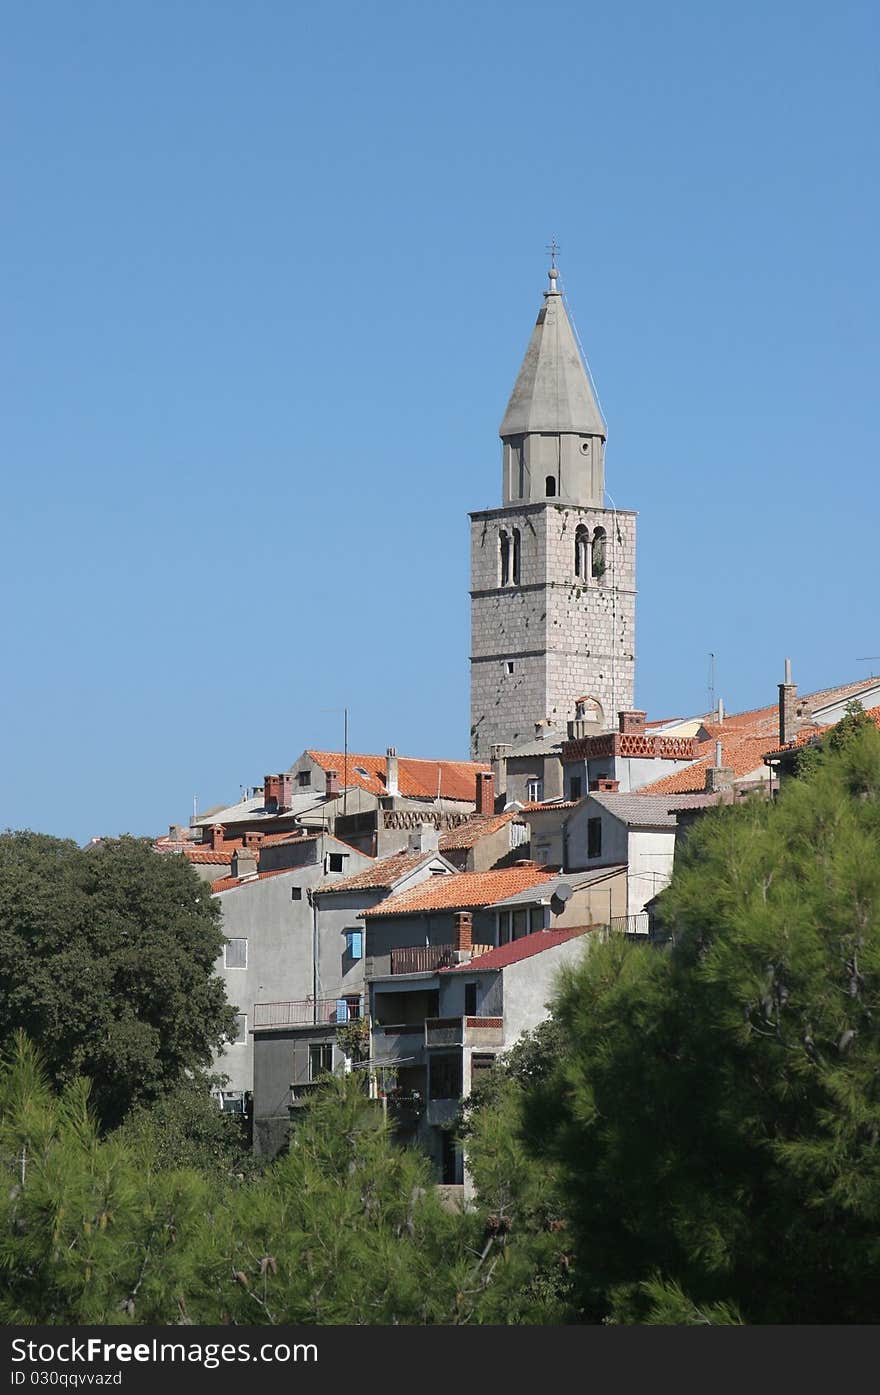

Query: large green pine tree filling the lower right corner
left=524, top=723, right=880, bottom=1322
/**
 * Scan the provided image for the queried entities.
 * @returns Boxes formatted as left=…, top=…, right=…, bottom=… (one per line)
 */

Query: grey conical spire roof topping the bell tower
left=498, top=258, right=608, bottom=439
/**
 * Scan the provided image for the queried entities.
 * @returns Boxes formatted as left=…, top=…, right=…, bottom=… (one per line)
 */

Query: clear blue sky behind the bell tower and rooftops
left=0, top=0, right=880, bottom=841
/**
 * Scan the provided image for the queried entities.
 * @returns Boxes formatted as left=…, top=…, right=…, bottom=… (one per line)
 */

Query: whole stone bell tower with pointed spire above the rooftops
left=470, top=257, right=636, bottom=760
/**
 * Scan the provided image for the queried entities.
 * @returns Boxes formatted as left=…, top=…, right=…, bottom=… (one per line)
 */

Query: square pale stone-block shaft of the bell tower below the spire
left=471, top=504, right=636, bottom=759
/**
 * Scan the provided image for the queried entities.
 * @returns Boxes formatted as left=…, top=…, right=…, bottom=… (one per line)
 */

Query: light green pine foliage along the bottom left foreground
left=0, top=1038, right=555, bottom=1324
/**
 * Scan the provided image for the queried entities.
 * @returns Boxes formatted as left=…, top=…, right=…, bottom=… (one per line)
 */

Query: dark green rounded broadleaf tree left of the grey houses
left=0, top=833, right=234, bottom=1127
